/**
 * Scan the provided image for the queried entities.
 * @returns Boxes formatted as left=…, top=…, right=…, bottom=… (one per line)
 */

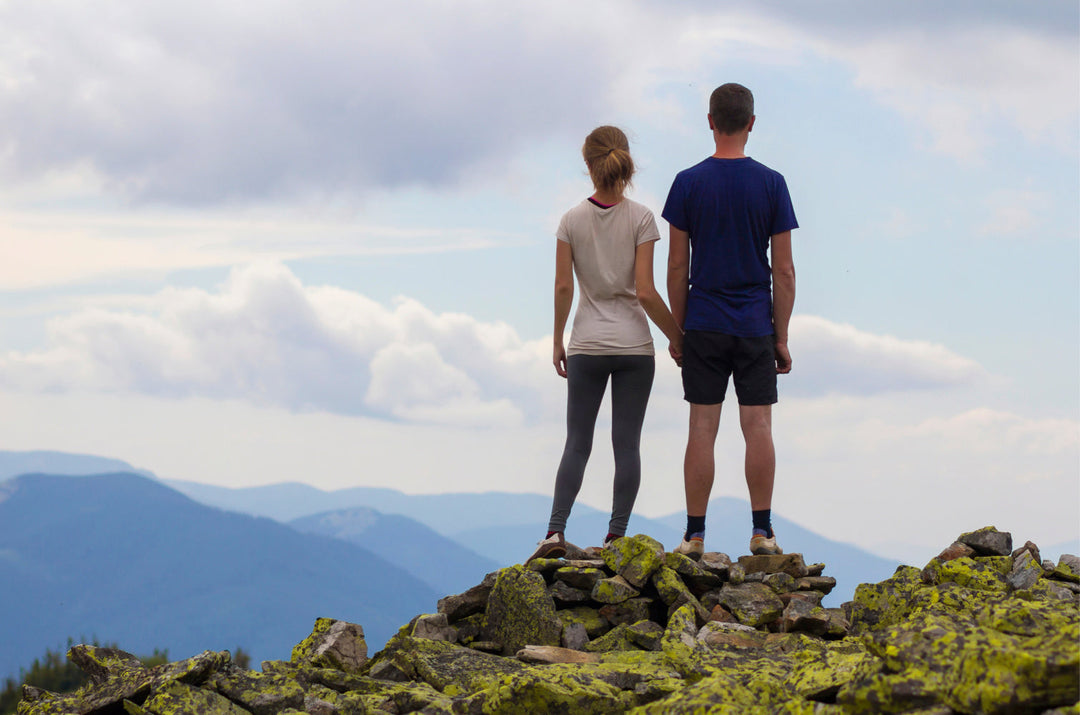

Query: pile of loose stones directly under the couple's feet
left=413, top=535, right=850, bottom=662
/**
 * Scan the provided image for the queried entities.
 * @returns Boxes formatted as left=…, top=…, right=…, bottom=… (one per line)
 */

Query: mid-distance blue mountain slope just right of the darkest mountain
left=289, top=507, right=501, bottom=594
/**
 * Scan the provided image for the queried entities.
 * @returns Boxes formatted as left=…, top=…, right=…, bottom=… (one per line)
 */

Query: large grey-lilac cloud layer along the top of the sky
left=0, top=0, right=1078, bottom=206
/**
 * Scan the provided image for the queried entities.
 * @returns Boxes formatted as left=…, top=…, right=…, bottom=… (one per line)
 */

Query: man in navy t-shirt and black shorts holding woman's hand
left=663, top=84, right=798, bottom=558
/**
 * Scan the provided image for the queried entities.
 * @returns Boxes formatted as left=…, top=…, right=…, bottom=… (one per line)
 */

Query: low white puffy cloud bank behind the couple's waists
left=0, top=264, right=985, bottom=424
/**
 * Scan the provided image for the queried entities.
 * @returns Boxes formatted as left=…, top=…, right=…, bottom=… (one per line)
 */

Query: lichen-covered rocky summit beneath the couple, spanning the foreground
left=12, top=527, right=1080, bottom=715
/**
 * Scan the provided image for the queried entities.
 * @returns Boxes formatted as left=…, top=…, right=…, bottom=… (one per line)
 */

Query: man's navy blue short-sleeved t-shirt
left=662, top=157, right=798, bottom=338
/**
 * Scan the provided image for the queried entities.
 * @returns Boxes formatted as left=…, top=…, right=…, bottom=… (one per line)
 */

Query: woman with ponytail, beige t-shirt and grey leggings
left=526, top=126, right=683, bottom=563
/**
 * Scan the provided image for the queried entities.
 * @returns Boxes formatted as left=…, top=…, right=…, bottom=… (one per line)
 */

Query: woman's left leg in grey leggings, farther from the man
left=548, top=355, right=611, bottom=531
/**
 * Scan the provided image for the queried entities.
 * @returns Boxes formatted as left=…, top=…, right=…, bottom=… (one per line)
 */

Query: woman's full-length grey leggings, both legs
left=548, top=355, right=657, bottom=536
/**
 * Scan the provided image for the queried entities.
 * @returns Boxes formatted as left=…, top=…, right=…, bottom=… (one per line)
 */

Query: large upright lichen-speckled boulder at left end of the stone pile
left=484, top=565, right=563, bottom=656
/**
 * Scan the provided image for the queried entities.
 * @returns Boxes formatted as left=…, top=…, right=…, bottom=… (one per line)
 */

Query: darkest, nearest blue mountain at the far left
left=0, top=473, right=444, bottom=678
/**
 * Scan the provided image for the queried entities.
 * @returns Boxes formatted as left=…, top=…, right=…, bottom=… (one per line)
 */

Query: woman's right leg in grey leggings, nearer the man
left=608, top=355, right=657, bottom=536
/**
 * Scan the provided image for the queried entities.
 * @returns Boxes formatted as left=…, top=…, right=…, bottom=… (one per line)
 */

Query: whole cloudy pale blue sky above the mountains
left=0, top=0, right=1080, bottom=555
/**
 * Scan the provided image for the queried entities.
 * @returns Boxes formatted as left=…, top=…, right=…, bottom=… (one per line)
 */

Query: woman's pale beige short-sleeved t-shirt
left=555, top=199, right=660, bottom=355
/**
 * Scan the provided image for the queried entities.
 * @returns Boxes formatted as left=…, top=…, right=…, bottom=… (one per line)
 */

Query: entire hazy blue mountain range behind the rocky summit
left=0, top=451, right=1080, bottom=691
